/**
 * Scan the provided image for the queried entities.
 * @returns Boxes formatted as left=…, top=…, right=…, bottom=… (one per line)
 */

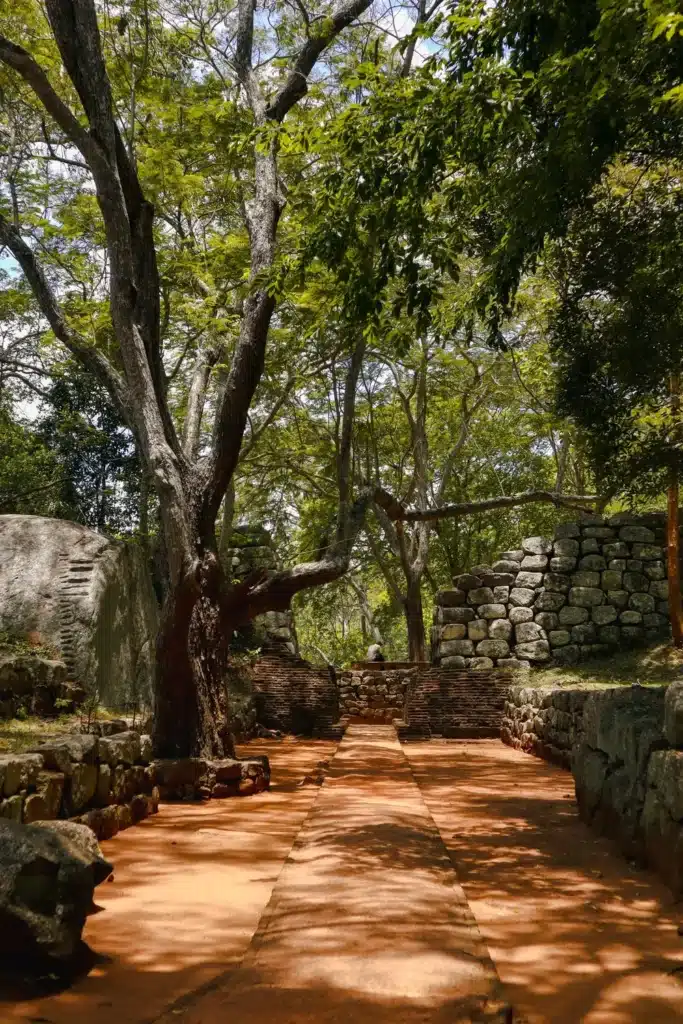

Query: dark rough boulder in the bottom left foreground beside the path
left=0, top=820, right=113, bottom=965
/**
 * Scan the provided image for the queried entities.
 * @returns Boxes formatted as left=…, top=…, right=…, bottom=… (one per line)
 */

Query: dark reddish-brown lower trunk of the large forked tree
left=153, top=552, right=233, bottom=758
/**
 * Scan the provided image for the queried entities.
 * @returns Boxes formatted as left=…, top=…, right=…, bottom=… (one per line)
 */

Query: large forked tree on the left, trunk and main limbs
left=0, top=0, right=371, bottom=756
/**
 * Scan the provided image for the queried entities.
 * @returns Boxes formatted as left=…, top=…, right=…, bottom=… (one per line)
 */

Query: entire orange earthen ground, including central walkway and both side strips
left=0, top=726, right=683, bottom=1024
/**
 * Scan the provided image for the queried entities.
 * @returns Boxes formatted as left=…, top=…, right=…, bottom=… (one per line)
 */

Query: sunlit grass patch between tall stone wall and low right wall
left=520, top=644, right=683, bottom=689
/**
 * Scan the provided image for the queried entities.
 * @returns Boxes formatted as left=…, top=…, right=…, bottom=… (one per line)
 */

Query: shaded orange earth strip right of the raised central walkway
left=405, top=740, right=683, bottom=1024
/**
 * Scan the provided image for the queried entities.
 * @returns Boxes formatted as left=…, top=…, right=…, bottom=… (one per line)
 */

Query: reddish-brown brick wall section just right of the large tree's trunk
left=252, top=649, right=342, bottom=738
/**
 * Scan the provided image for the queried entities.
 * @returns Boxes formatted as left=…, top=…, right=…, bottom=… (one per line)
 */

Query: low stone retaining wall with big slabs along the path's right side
left=501, top=683, right=683, bottom=895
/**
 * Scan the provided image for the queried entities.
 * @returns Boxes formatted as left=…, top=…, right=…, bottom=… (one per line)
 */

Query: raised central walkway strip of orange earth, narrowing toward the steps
left=154, top=726, right=504, bottom=1024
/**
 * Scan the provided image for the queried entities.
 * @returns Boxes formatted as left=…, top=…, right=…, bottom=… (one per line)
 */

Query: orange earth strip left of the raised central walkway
left=0, top=740, right=336, bottom=1024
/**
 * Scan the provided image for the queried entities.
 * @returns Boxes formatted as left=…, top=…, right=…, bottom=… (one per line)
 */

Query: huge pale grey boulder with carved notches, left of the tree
left=0, top=515, right=159, bottom=702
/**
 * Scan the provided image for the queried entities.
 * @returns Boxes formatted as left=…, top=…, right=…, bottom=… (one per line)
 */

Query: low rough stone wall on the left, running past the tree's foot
left=0, top=730, right=270, bottom=839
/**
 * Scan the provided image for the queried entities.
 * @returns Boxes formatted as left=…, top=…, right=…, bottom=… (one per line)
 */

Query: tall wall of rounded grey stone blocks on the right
left=432, top=514, right=670, bottom=671
